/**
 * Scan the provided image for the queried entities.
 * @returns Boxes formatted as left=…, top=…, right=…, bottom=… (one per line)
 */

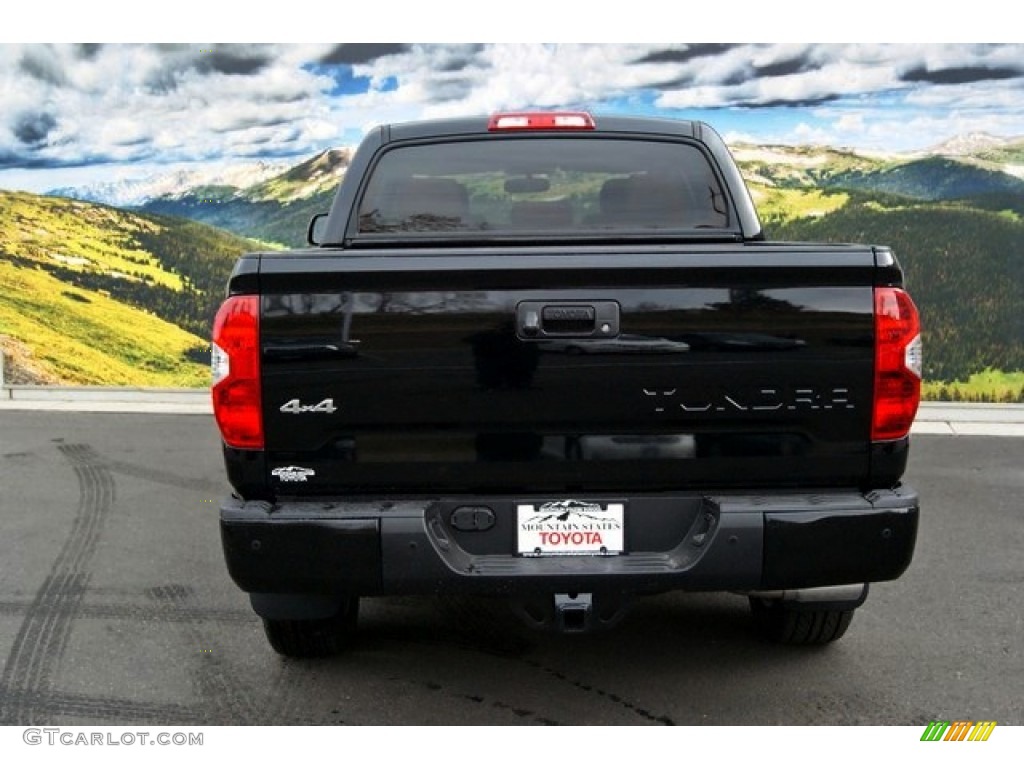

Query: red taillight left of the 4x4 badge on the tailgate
left=210, top=296, right=263, bottom=451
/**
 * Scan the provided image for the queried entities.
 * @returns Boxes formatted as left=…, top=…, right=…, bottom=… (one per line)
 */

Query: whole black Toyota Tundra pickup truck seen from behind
left=212, top=113, right=921, bottom=656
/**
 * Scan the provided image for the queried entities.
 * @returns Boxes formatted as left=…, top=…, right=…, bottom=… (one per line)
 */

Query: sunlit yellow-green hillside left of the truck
left=0, top=191, right=254, bottom=386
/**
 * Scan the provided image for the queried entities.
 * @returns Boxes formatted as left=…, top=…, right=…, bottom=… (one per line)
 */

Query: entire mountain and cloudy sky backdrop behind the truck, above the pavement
left=0, top=43, right=1024, bottom=399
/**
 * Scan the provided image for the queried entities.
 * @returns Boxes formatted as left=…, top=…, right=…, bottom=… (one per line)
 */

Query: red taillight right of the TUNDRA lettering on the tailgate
left=871, top=288, right=922, bottom=440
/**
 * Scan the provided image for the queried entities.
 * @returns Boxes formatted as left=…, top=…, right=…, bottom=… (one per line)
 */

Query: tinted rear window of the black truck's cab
left=357, top=134, right=732, bottom=239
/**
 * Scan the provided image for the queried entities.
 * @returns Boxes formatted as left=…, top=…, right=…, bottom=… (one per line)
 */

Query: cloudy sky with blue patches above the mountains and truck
left=0, top=43, right=1024, bottom=191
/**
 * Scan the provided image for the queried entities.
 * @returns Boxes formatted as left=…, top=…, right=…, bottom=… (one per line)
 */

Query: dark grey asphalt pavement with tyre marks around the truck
left=0, top=409, right=1024, bottom=729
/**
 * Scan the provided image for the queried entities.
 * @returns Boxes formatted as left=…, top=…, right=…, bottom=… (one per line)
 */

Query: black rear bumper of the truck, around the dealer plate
left=220, top=486, right=919, bottom=596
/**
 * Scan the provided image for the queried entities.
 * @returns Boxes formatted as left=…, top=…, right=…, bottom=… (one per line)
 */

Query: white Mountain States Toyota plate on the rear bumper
left=516, top=499, right=626, bottom=557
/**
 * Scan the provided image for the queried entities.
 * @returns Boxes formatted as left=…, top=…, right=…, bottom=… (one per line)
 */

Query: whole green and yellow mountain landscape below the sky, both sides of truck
left=0, top=134, right=1024, bottom=398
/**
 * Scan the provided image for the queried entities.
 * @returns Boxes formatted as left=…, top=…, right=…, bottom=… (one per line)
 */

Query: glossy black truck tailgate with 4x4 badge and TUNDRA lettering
left=259, top=244, right=874, bottom=496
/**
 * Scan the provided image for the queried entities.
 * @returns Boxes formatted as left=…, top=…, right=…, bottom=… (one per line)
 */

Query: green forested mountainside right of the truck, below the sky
left=734, top=141, right=1024, bottom=400
